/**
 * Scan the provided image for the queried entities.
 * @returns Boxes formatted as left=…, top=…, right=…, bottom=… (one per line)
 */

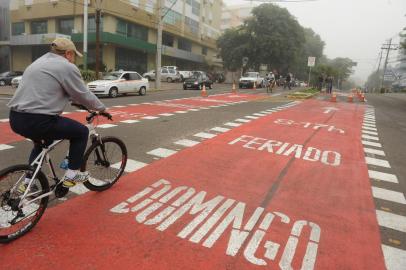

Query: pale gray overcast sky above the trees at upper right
left=224, top=0, right=406, bottom=80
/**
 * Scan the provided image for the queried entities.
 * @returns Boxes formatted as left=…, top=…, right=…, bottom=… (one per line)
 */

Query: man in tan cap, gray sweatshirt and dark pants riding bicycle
left=7, top=38, right=106, bottom=187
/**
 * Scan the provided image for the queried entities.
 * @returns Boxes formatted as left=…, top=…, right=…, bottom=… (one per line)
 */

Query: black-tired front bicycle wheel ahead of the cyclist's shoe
left=81, top=137, right=127, bottom=191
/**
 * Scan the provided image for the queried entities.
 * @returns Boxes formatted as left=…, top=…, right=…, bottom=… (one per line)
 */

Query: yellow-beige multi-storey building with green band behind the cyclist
left=10, top=0, right=222, bottom=73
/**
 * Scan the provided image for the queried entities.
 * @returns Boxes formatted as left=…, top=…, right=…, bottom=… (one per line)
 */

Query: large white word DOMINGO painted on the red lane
left=110, top=179, right=321, bottom=270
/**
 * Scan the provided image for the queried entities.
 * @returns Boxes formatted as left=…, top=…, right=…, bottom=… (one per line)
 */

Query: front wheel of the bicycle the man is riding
left=81, top=137, right=127, bottom=191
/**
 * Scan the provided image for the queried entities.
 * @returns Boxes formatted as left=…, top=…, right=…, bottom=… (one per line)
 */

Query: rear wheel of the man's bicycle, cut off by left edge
left=0, top=165, right=49, bottom=243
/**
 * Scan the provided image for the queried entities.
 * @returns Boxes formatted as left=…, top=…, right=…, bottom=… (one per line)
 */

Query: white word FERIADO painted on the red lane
left=228, top=135, right=341, bottom=166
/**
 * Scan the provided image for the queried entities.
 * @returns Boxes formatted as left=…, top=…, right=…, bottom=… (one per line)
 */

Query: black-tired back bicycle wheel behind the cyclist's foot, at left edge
left=0, top=165, right=49, bottom=243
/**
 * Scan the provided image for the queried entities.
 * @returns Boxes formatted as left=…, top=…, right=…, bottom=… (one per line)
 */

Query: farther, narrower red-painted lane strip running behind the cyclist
left=0, top=94, right=266, bottom=147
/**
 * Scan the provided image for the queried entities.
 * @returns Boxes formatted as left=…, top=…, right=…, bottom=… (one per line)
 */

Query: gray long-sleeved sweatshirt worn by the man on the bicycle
left=7, top=52, right=106, bottom=115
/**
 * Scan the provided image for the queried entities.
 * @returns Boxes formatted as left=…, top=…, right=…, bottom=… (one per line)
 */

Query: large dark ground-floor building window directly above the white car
left=115, top=47, right=147, bottom=74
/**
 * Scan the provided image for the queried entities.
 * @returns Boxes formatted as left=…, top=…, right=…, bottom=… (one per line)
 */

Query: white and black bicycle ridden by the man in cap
left=0, top=104, right=127, bottom=243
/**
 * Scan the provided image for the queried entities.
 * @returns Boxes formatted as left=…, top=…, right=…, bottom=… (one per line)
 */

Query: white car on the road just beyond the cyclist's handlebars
left=87, top=71, right=149, bottom=98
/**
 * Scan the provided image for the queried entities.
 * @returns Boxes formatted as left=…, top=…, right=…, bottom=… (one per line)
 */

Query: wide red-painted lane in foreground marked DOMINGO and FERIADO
left=0, top=101, right=385, bottom=269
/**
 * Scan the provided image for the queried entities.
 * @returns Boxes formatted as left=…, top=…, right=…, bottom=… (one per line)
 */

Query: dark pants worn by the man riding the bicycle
left=10, top=111, right=89, bottom=170
